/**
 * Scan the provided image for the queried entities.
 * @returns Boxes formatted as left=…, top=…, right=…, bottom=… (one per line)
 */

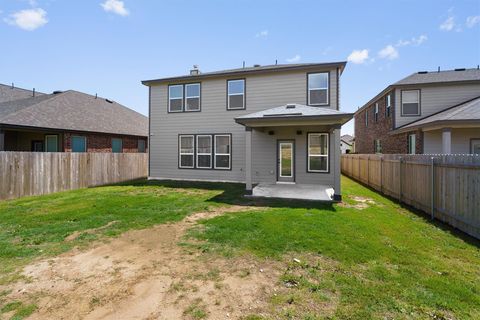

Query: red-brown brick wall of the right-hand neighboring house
left=354, top=91, right=423, bottom=154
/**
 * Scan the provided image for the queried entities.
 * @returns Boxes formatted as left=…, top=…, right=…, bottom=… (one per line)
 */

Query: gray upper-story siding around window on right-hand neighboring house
left=395, top=84, right=480, bottom=128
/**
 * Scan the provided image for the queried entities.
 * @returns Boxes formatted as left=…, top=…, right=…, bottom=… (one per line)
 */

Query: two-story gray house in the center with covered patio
left=142, top=62, right=352, bottom=199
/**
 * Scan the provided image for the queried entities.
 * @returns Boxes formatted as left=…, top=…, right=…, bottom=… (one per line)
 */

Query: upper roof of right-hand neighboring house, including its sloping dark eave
left=355, top=68, right=480, bottom=114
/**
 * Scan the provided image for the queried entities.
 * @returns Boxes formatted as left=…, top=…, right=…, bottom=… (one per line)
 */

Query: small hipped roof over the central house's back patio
left=235, top=103, right=353, bottom=127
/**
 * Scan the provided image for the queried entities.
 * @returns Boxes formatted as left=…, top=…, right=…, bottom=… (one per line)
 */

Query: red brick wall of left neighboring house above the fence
left=63, top=133, right=148, bottom=153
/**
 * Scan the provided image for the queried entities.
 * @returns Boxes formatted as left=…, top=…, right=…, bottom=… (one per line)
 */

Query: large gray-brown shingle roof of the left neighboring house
left=0, top=90, right=148, bottom=137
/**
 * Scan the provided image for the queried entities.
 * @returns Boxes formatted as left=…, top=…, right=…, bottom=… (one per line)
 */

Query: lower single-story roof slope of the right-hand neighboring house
left=394, top=96, right=480, bottom=133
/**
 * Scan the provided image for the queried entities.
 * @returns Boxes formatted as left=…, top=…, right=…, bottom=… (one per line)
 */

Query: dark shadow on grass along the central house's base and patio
left=117, top=179, right=336, bottom=211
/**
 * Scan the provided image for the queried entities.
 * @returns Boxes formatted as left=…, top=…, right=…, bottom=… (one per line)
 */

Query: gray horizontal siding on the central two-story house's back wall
left=149, top=69, right=337, bottom=184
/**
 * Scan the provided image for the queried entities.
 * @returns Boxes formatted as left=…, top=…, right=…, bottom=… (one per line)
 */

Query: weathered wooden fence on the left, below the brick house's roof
left=0, top=152, right=148, bottom=200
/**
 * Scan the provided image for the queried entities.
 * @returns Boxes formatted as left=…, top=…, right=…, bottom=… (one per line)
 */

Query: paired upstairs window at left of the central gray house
left=168, top=83, right=201, bottom=112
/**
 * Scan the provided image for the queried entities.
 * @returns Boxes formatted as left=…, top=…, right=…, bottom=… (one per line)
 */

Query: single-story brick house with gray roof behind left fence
left=0, top=85, right=148, bottom=152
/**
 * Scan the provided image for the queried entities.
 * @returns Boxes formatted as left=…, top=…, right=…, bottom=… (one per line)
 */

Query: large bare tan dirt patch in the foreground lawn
left=0, top=206, right=284, bottom=319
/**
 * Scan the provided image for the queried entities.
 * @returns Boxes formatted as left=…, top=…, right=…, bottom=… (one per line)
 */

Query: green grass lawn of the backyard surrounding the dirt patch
left=0, top=178, right=480, bottom=319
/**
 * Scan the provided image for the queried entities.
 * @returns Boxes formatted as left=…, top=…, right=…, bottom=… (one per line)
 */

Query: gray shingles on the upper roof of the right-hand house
left=393, top=68, right=480, bottom=85
